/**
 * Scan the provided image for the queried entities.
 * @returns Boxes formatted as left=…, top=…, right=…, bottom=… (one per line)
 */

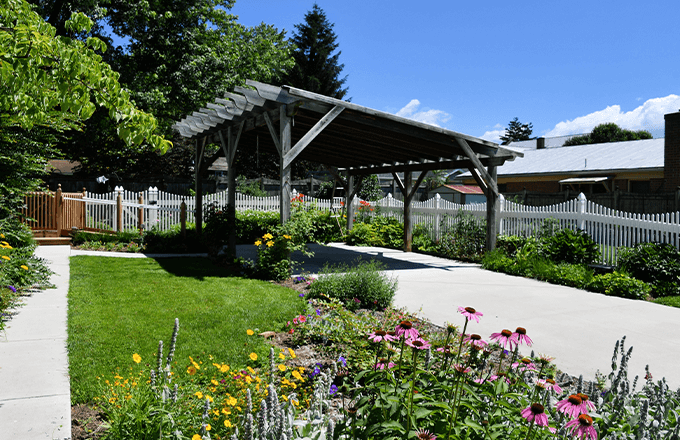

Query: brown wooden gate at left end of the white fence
left=21, top=185, right=85, bottom=236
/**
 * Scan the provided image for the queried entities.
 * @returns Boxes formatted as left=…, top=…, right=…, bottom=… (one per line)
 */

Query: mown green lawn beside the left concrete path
left=68, top=256, right=304, bottom=403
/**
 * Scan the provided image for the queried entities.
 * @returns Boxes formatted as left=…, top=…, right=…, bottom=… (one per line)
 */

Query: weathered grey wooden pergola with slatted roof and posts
left=173, top=80, right=523, bottom=254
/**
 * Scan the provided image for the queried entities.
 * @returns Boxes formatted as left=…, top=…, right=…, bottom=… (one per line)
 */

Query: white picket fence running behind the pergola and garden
left=83, top=187, right=680, bottom=264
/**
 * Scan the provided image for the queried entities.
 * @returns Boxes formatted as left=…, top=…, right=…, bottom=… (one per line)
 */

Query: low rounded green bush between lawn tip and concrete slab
left=310, top=259, right=397, bottom=310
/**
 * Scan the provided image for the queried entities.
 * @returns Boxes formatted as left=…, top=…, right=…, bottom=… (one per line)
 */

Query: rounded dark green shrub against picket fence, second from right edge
left=539, top=229, right=600, bottom=264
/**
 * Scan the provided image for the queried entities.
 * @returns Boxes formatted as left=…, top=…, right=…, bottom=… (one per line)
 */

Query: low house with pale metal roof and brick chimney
left=453, top=111, right=680, bottom=195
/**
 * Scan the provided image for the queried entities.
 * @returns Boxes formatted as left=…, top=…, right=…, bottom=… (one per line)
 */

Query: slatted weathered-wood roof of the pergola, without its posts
left=173, top=81, right=522, bottom=174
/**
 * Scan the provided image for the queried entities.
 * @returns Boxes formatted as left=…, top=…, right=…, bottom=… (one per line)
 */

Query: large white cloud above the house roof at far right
left=545, top=95, right=680, bottom=137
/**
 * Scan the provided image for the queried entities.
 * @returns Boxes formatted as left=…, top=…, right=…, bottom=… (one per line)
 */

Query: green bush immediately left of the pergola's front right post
left=437, top=210, right=486, bottom=261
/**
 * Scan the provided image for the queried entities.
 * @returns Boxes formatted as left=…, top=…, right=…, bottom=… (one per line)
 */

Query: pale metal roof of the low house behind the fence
left=462, top=138, right=664, bottom=177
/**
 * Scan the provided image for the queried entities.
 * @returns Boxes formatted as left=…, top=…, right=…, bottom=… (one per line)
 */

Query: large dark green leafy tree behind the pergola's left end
left=29, top=0, right=293, bottom=177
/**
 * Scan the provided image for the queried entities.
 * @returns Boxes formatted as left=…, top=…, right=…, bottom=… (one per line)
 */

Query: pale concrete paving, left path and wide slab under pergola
left=0, top=244, right=680, bottom=439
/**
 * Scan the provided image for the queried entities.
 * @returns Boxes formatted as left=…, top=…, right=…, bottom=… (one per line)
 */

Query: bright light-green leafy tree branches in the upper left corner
left=0, top=0, right=171, bottom=217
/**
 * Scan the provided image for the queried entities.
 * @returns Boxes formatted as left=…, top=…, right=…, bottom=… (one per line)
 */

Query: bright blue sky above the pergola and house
left=231, top=0, right=680, bottom=141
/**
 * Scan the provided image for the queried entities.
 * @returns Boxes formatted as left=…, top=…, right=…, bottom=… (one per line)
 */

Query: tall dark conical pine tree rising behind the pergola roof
left=283, top=4, right=347, bottom=99
